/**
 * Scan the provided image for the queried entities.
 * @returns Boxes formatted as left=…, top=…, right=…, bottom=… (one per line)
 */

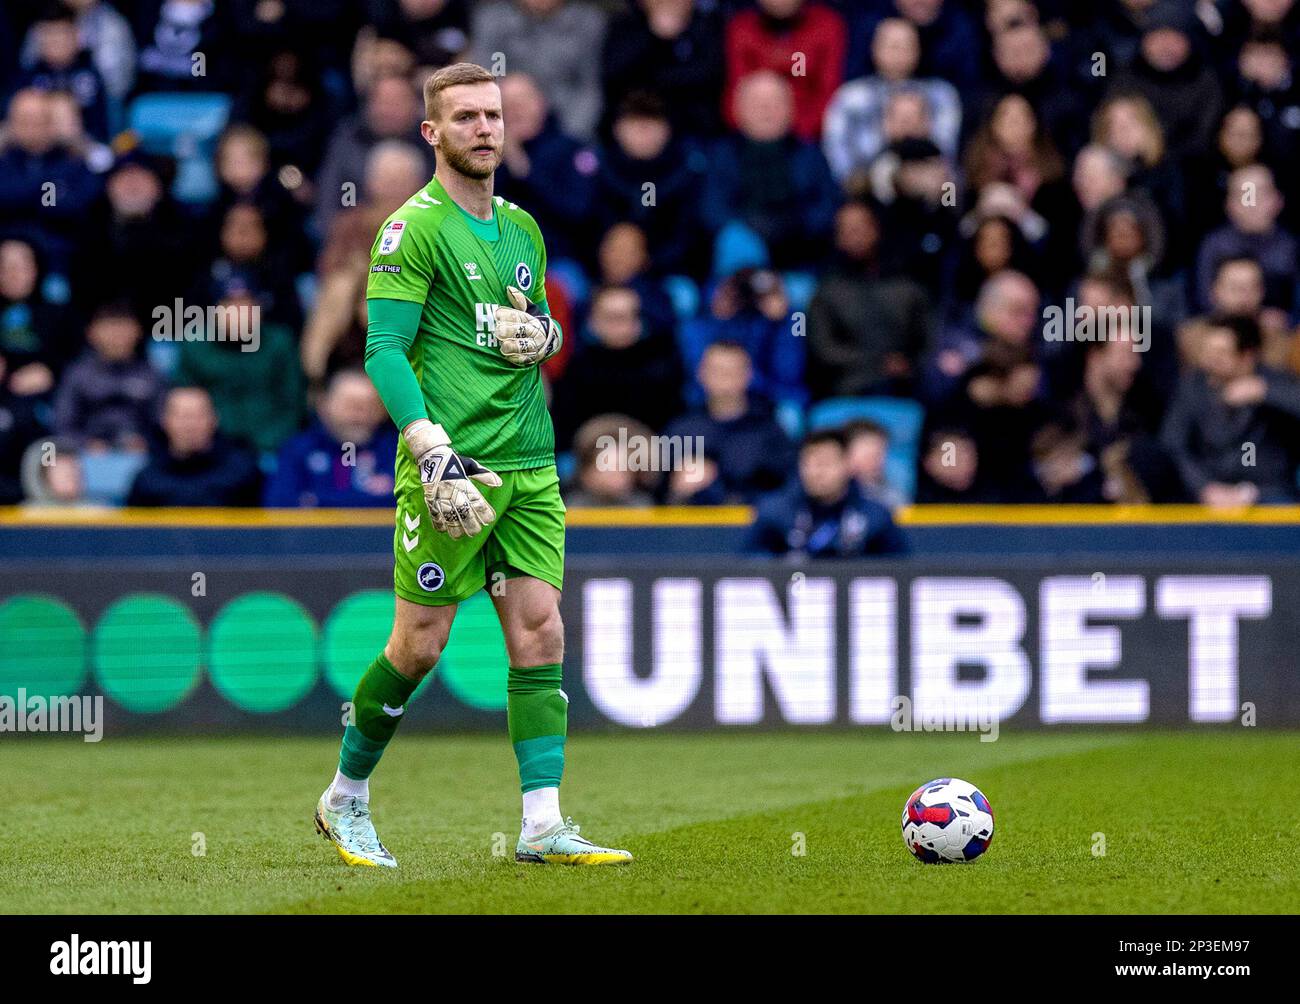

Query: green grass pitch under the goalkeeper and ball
left=0, top=731, right=1300, bottom=913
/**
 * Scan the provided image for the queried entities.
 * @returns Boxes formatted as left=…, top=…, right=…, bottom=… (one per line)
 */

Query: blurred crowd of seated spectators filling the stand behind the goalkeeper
left=0, top=0, right=1300, bottom=551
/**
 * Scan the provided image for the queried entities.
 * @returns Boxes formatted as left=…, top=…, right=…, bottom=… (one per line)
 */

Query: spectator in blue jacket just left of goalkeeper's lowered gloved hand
left=263, top=369, right=398, bottom=509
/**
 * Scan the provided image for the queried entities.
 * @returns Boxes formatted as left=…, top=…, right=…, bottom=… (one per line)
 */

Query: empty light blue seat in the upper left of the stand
left=127, top=94, right=230, bottom=203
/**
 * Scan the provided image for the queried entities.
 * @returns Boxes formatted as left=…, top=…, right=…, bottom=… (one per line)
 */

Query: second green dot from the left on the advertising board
left=94, top=593, right=202, bottom=714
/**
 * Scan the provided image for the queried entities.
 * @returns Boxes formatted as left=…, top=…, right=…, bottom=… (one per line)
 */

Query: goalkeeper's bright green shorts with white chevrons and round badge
left=393, top=464, right=564, bottom=606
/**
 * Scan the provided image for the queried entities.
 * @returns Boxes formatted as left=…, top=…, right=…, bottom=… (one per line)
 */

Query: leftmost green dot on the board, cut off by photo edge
left=0, top=593, right=86, bottom=700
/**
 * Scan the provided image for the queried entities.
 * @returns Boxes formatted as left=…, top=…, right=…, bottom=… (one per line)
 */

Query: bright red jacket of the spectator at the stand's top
left=723, top=0, right=848, bottom=140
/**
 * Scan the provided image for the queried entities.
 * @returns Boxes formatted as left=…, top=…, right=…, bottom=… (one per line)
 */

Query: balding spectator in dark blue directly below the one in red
left=701, top=70, right=836, bottom=268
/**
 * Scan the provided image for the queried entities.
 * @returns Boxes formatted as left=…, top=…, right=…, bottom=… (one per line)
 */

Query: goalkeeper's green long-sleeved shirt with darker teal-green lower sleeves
left=365, top=178, right=555, bottom=485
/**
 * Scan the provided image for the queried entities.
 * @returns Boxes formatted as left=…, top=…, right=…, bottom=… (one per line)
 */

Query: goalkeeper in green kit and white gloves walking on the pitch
left=316, top=62, right=632, bottom=867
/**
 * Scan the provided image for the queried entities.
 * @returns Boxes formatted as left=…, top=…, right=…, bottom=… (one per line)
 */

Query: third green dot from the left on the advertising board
left=208, top=592, right=316, bottom=714
